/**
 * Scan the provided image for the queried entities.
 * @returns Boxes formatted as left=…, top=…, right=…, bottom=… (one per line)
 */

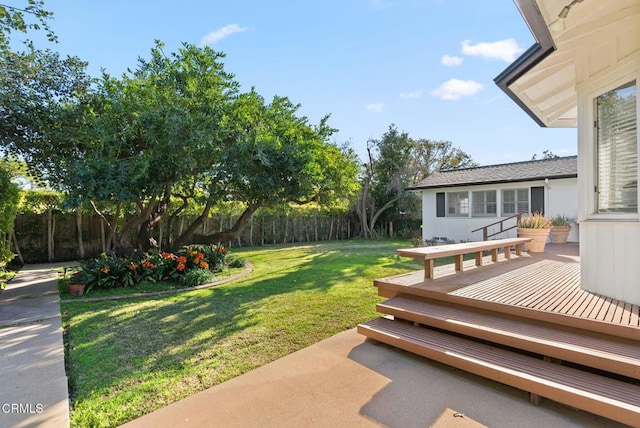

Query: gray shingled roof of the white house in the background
left=408, top=156, right=578, bottom=190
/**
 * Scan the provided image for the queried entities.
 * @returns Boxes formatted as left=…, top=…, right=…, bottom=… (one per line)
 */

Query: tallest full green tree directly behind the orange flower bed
left=56, top=42, right=237, bottom=252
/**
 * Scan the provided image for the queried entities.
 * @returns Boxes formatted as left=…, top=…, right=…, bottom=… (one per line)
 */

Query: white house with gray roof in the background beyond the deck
left=411, top=156, right=578, bottom=242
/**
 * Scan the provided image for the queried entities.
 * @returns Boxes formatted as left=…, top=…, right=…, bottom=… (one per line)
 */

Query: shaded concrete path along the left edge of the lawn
left=0, top=264, right=69, bottom=428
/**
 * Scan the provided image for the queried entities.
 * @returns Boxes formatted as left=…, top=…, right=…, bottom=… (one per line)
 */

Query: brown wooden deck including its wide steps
left=358, top=244, right=640, bottom=426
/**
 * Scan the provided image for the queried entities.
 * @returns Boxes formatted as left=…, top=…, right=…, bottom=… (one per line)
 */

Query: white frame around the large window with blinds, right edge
left=578, top=69, right=640, bottom=221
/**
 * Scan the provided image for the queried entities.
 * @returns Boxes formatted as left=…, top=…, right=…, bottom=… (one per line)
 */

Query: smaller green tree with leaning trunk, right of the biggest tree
left=171, top=90, right=358, bottom=244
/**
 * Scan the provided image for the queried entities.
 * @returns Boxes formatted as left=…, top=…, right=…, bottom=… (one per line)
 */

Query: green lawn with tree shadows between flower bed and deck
left=62, top=241, right=430, bottom=427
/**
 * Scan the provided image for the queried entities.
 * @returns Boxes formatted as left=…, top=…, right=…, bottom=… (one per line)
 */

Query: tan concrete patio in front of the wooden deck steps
left=123, top=329, right=620, bottom=428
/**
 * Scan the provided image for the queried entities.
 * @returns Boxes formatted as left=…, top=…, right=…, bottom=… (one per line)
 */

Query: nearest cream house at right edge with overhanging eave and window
left=495, top=0, right=640, bottom=304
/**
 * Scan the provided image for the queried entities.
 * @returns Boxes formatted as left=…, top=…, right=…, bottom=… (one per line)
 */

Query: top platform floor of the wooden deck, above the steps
left=376, top=245, right=640, bottom=336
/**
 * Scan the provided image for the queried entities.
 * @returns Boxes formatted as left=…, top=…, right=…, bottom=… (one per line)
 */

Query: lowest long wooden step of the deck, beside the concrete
left=358, top=318, right=640, bottom=425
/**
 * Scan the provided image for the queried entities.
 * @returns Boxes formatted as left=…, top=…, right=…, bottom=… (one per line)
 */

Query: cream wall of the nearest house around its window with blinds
left=576, top=20, right=640, bottom=304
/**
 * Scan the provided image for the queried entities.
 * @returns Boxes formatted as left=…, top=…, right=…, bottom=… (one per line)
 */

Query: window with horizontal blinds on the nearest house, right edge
left=595, top=81, right=638, bottom=213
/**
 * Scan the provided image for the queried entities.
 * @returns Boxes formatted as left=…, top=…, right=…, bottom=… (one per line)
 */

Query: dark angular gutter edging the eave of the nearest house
left=493, top=0, right=556, bottom=128
